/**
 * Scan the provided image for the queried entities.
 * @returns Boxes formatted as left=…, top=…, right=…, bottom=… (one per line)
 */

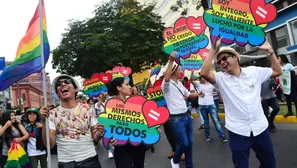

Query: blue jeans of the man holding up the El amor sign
left=170, top=114, right=193, bottom=168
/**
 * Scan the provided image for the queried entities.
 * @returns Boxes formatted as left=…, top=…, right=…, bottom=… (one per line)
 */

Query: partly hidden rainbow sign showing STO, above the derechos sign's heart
left=146, top=80, right=167, bottom=106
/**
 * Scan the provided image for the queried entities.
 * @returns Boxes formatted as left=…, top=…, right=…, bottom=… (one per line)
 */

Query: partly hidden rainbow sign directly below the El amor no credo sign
left=180, top=48, right=209, bottom=71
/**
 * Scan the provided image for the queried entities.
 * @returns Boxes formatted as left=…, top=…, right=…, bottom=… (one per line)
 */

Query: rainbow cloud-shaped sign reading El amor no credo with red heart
left=163, top=16, right=208, bottom=60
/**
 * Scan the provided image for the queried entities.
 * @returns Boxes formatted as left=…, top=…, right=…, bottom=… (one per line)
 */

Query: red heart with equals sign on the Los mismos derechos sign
left=142, top=100, right=169, bottom=128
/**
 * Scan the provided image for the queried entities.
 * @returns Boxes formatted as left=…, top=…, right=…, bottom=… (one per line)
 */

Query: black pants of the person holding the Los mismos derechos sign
left=114, top=145, right=145, bottom=168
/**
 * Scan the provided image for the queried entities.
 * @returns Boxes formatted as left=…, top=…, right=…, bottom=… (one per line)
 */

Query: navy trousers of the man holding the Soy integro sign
left=229, top=129, right=276, bottom=168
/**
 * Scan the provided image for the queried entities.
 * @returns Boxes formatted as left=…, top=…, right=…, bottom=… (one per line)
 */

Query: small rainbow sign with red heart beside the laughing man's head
left=82, top=73, right=112, bottom=97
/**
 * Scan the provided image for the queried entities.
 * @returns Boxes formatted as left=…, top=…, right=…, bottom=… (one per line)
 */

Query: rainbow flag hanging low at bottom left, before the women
left=5, top=142, right=31, bottom=168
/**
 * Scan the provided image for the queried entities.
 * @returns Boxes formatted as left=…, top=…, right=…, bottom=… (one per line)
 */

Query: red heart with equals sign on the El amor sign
left=187, top=16, right=206, bottom=36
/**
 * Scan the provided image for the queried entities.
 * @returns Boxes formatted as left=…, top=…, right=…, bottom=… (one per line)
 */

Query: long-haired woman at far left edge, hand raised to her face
left=0, top=111, right=29, bottom=168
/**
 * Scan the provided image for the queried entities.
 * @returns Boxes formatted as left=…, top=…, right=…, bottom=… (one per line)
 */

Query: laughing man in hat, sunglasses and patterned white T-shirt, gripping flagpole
left=40, top=75, right=104, bottom=168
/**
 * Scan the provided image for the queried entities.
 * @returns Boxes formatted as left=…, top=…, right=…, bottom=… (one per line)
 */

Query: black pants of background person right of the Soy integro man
left=262, top=97, right=280, bottom=128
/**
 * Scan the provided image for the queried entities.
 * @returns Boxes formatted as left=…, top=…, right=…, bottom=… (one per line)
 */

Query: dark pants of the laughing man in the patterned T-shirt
left=58, top=155, right=101, bottom=168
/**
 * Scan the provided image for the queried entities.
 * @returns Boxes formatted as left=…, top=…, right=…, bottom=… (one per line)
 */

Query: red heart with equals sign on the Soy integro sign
left=250, top=0, right=277, bottom=25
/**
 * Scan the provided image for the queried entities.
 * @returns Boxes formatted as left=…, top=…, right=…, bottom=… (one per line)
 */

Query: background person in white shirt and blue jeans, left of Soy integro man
left=195, top=77, right=228, bottom=143
